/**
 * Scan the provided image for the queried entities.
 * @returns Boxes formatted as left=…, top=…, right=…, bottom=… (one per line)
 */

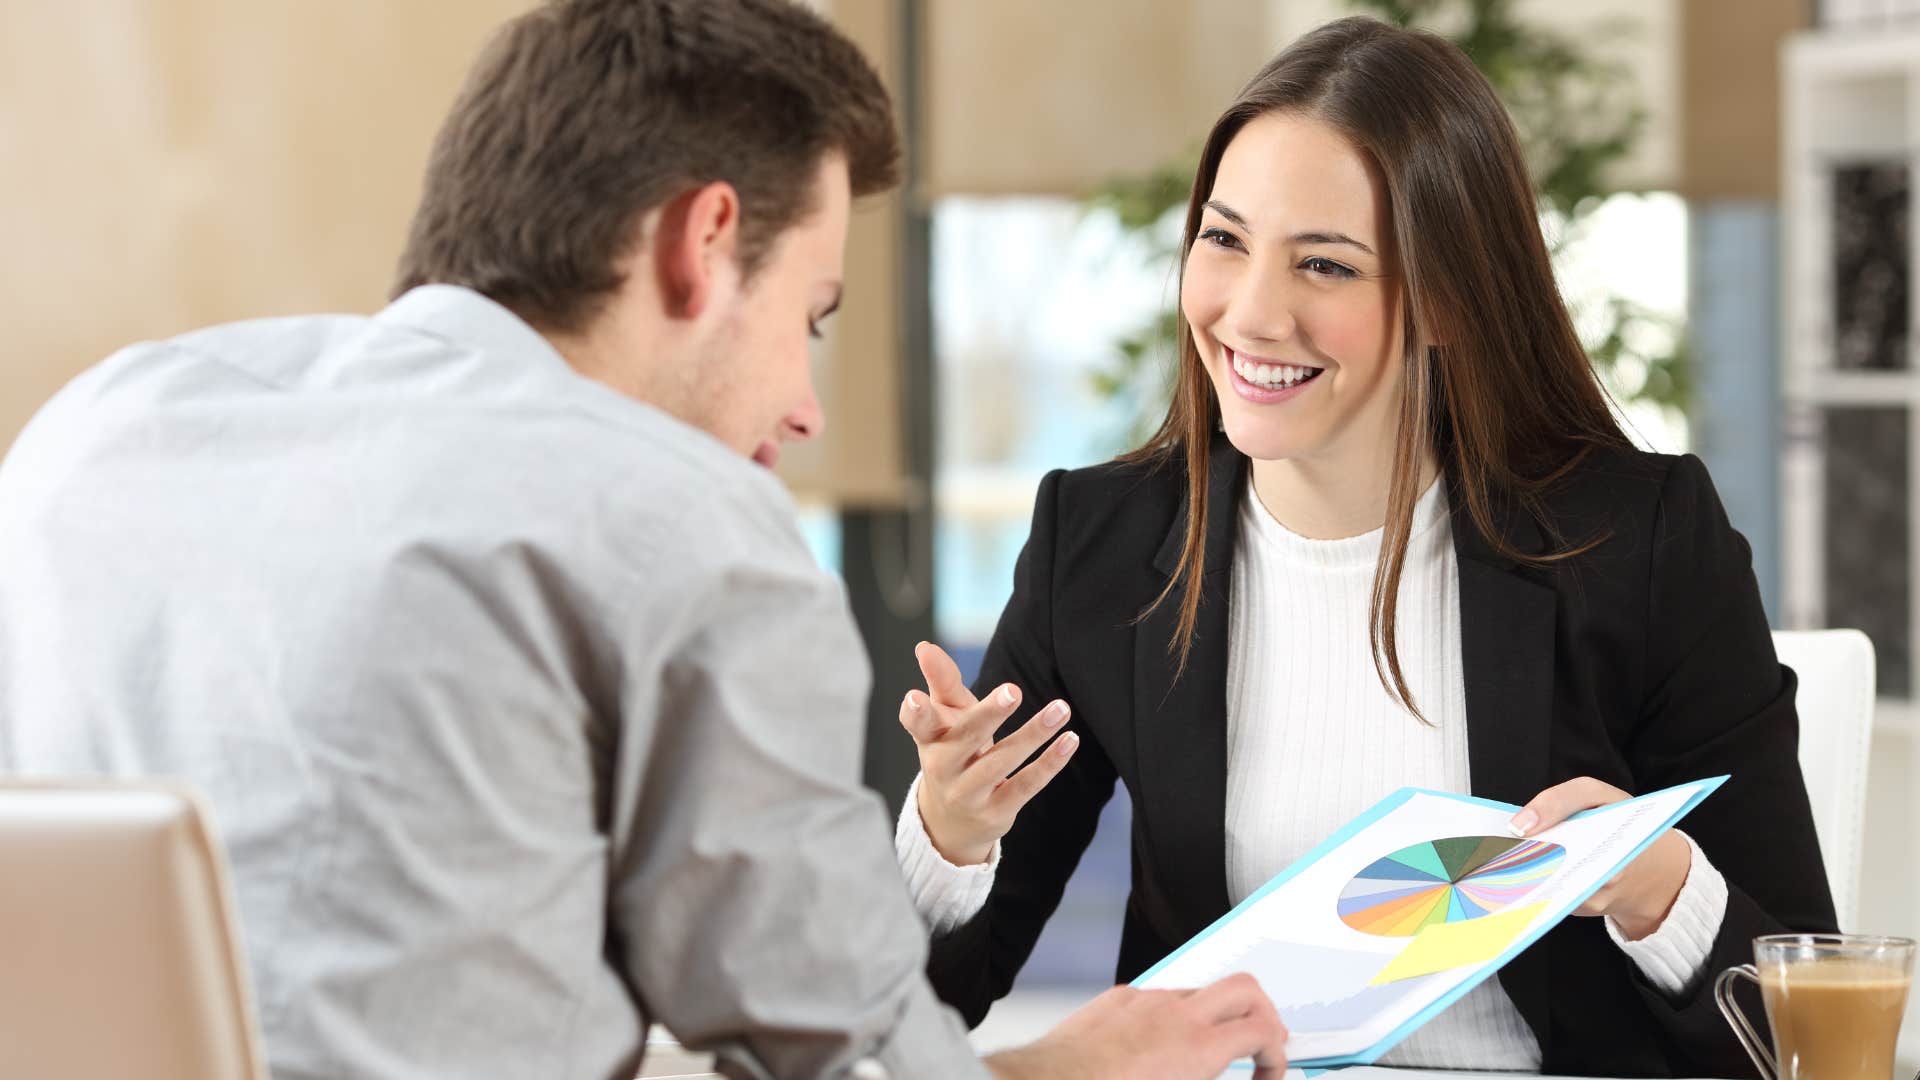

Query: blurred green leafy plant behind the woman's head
left=1087, top=0, right=1693, bottom=444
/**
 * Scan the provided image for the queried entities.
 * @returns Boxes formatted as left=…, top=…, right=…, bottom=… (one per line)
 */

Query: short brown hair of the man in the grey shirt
left=394, top=0, right=900, bottom=332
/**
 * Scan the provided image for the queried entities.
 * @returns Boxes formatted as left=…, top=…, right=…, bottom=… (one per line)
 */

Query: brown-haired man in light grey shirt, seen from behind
left=0, top=0, right=1284, bottom=1080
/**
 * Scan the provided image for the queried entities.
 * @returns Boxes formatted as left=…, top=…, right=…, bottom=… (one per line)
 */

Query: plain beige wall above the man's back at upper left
left=0, top=0, right=530, bottom=446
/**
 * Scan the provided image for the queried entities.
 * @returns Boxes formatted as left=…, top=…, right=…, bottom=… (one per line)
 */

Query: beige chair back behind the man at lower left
left=0, top=780, right=265, bottom=1080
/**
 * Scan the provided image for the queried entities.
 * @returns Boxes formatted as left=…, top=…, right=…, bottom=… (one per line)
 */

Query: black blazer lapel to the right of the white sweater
left=1452, top=478, right=1557, bottom=1047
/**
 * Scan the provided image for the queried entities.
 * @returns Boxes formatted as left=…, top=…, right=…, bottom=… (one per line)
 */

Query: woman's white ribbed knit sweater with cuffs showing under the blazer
left=895, top=474, right=1726, bottom=1070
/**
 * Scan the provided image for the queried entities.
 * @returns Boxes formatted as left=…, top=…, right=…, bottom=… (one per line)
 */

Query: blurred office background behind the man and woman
left=0, top=0, right=1920, bottom=1060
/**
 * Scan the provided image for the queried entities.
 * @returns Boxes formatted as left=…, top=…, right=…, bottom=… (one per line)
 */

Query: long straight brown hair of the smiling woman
left=1123, top=15, right=1628, bottom=721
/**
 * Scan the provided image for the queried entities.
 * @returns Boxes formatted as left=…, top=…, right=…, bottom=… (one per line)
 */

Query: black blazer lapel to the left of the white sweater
left=1133, top=434, right=1246, bottom=936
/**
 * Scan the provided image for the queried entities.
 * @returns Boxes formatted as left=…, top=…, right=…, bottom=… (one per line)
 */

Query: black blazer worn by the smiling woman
left=927, top=436, right=1836, bottom=1076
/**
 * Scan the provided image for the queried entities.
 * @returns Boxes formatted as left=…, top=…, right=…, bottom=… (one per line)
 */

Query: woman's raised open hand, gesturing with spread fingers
left=900, top=642, right=1079, bottom=867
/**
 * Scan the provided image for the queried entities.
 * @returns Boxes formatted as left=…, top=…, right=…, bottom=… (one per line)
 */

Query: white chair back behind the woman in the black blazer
left=1774, top=630, right=1874, bottom=930
